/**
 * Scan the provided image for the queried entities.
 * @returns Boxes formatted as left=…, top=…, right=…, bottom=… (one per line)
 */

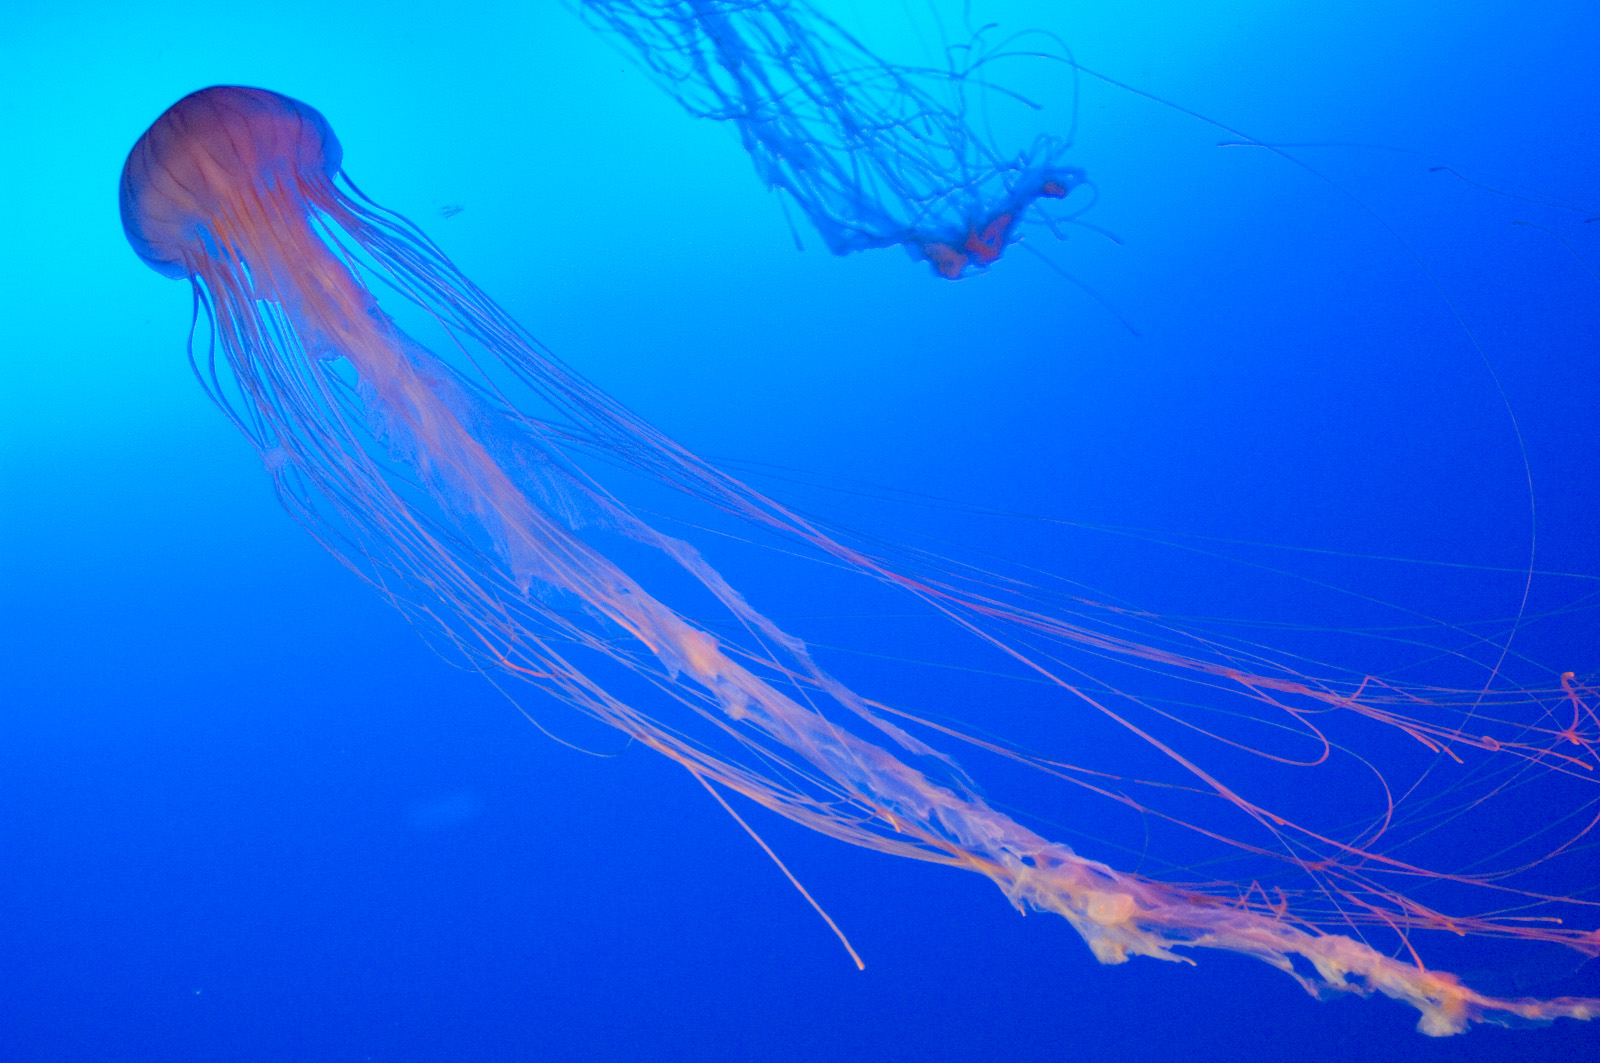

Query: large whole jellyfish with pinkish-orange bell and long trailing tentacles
left=120, top=86, right=1600, bottom=1036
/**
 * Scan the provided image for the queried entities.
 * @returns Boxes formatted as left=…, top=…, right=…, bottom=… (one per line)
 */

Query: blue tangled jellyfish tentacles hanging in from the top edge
left=578, top=0, right=1085, bottom=280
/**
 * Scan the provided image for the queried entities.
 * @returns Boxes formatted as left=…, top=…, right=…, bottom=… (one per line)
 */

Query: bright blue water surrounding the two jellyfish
left=0, top=0, right=1600, bottom=1061
